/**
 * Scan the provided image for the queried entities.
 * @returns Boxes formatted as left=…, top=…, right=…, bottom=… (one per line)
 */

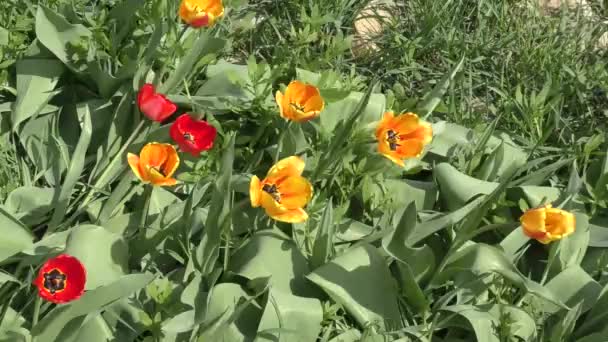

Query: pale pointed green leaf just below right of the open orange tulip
left=433, top=163, right=499, bottom=210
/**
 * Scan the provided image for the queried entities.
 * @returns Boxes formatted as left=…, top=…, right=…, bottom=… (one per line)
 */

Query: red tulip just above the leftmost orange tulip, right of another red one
left=169, top=114, right=217, bottom=156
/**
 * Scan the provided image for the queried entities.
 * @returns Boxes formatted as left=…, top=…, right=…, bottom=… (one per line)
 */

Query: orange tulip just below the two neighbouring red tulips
left=127, top=142, right=179, bottom=186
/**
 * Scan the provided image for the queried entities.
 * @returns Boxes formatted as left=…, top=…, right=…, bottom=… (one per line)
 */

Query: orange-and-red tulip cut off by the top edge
left=179, top=0, right=224, bottom=27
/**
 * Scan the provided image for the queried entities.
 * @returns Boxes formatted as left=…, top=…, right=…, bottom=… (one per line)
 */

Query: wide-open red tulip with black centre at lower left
left=34, top=254, right=87, bottom=303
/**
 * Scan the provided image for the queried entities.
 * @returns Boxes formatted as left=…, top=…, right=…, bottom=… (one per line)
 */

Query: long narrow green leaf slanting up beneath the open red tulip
left=32, top=274, right=154, bottom=341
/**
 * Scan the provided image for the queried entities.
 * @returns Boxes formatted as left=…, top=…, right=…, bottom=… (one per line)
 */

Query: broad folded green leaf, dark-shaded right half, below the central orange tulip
left=307, top=245, right=401, bottom=329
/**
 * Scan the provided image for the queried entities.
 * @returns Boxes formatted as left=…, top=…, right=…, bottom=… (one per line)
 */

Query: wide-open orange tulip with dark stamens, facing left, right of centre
left=376, top=112, right=433, bottom=166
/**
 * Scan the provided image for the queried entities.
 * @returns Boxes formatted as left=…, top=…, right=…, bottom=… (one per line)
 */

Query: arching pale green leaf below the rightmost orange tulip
left=435, top=243, right=564, bottom=307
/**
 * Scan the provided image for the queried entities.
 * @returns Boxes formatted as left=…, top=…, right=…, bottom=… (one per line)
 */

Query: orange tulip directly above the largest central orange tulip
left=275, top=81, right=325, bottom=122
